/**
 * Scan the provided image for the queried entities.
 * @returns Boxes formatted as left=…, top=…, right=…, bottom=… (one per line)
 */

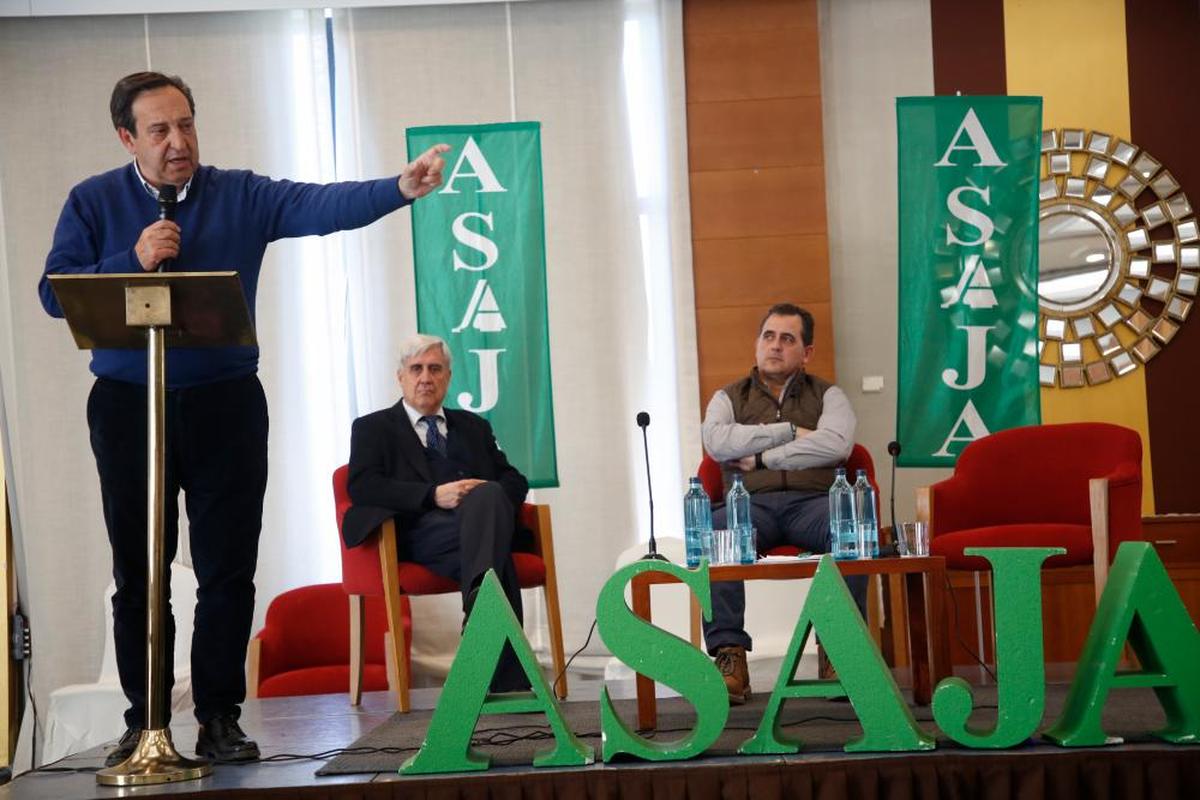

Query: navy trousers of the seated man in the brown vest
left=704, top=492, right=868, bottom=655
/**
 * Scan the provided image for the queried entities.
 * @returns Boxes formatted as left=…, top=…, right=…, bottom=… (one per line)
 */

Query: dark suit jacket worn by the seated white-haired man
left=342, top=403, right=529, bottom=547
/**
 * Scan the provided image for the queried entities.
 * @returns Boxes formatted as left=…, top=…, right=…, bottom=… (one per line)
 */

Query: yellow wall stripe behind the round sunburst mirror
left=1004, top=0, right=1154, bottom=513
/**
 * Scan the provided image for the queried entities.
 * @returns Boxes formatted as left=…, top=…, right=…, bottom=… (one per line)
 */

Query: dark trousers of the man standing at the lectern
left=88, top=375, right=268, bottom=727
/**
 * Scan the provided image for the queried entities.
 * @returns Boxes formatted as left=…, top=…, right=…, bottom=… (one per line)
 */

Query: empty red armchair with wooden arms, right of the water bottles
left=917, top=422, right=1141, bottom=597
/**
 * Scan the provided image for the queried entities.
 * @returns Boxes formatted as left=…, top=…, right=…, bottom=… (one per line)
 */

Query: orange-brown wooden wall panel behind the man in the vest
left=683, top=0, right=835, bottom=408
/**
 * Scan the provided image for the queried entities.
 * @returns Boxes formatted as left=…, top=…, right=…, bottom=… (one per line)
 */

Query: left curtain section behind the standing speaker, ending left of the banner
left=0, top=11, right=348, bottom=762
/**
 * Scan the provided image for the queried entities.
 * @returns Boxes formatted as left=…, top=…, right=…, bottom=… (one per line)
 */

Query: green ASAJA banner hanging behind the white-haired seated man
left=407, top=122, right=558, bottom=487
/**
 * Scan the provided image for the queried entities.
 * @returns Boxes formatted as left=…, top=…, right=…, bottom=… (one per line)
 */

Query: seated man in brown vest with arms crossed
left=702, top=302, right=866, bottom=703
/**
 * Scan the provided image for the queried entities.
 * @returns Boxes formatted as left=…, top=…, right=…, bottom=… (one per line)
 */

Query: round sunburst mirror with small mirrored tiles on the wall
left=1038, top=130, right=1200, bottom=389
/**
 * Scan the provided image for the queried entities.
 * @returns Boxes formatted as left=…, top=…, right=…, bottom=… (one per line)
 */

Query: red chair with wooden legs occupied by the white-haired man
left=334, top=465, right=566, bottom=711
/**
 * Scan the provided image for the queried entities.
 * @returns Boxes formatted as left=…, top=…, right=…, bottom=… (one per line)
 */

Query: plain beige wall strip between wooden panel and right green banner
left=818, top=0, right=949, bottom=522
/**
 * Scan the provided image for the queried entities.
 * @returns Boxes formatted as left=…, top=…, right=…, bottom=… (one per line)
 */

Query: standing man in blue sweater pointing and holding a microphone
left=38, top=72, right=449, bottom=765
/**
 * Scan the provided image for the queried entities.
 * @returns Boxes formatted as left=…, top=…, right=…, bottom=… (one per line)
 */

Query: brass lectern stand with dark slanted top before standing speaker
left=50, top=272, right=256, bottom=786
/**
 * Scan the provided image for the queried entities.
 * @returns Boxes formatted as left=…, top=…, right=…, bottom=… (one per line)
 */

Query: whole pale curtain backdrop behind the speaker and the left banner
left=0, top=0, right=701, bottom=762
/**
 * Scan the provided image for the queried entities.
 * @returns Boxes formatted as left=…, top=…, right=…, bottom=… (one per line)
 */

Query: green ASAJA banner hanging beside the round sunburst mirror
left=896, top=97, right=1042, bottom=467
